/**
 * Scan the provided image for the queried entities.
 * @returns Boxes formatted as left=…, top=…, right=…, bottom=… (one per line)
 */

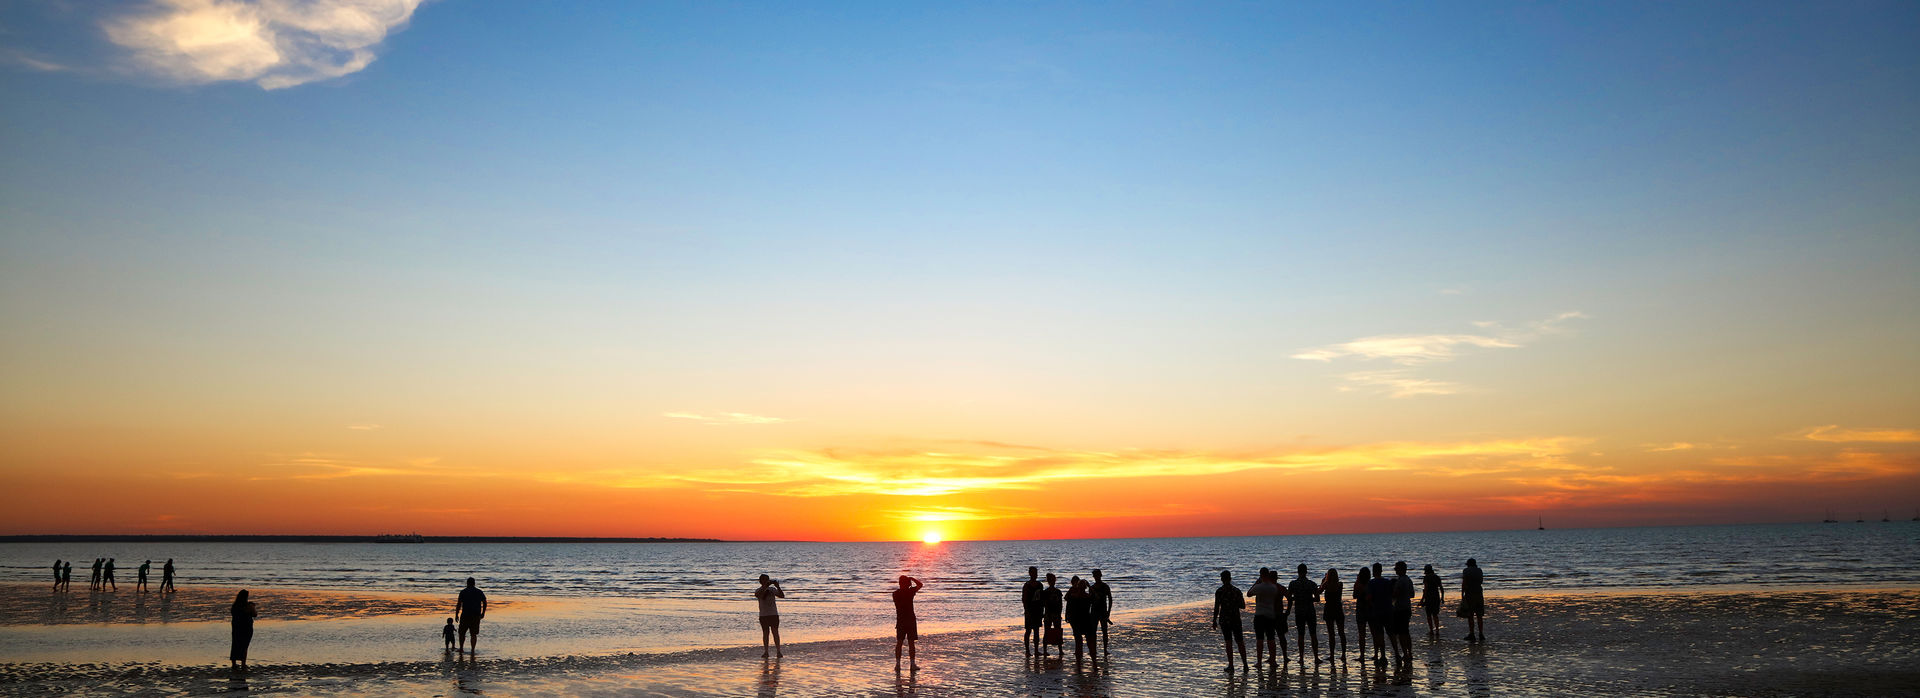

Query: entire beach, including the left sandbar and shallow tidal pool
left=0, top=585, right=1920, bottom=696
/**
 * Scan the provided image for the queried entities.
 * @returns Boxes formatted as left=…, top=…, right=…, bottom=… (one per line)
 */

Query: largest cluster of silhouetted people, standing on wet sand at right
left=1210, top=558, right=1486, bottom=671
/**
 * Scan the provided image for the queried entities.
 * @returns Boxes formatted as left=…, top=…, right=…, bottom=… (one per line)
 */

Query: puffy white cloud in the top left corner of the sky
left=102, top=0, right=420, bottom=90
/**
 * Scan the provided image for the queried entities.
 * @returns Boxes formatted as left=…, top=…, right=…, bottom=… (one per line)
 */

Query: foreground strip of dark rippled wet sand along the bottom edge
left=0, top=589, right=1920, bottom=696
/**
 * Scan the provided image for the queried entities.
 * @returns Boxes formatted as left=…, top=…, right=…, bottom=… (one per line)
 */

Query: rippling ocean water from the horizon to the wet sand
left=0, top=522, right=1920, bottom=662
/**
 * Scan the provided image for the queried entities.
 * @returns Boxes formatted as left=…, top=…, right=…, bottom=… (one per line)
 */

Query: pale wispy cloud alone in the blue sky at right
left=1292, top=311, right=1586, bottom=397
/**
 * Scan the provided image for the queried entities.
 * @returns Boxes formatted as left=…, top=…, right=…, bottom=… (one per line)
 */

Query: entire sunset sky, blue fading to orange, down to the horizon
left=0, top=0, right=1920, bottom=541
